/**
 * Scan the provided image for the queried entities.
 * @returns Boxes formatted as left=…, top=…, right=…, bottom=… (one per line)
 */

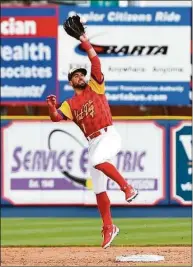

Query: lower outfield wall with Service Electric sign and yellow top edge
left=1, top=117, right=192, bottom=216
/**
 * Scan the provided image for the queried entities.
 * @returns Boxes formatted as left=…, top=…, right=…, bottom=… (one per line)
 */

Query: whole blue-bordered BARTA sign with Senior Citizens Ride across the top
left=58, top=6, right=191, bottom=105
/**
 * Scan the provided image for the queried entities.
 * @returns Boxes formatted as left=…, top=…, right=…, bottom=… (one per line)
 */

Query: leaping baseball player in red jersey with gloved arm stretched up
left=47, top=15, right=138, bottom=248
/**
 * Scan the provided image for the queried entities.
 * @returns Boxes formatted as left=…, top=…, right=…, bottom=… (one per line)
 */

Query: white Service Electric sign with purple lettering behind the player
left=2, top=121, right=165, bottom=205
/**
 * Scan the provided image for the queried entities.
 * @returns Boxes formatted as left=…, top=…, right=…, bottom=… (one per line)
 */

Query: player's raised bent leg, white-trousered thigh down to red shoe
left=90, top=126, right=138, bottom=202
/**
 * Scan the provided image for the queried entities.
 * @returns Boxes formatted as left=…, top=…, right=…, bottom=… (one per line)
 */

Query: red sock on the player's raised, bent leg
left=95, top=162, right=128, bottom=189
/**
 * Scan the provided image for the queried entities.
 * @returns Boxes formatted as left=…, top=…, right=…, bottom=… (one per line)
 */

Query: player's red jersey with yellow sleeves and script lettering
left=58, top=76, right=112, bottom=137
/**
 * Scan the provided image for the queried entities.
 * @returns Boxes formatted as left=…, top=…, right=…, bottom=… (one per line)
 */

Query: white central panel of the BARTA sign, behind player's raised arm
left=58, top=25, right=191, bottom=82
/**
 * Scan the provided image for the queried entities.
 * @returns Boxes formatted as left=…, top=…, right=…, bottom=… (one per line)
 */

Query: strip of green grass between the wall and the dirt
left=1, top=218, right=192, bottom=246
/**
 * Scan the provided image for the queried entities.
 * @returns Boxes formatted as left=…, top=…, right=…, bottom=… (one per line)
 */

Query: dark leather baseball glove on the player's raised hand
left=63, top=15, right=85, bottom=40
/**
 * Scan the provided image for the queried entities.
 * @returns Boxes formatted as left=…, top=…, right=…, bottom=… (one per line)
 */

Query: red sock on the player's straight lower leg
left=96, top=192, right=112, bottom=225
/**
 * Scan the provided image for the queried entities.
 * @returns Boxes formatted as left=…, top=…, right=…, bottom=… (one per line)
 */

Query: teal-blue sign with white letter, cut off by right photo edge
left=170, top=122, right=192, bottom=205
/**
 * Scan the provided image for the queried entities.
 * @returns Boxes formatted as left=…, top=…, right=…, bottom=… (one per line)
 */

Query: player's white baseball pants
left=88, top=125, right=121, bottom=194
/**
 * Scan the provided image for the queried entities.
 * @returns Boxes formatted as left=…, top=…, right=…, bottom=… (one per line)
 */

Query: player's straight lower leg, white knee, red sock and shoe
left=90, top=166, right=119, bottom=248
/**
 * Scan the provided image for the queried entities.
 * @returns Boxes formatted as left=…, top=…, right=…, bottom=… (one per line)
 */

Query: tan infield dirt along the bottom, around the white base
left=1, top=247, right=192, bottom=266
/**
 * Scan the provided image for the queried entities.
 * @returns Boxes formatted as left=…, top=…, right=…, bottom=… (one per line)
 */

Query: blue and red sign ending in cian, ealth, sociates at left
left=1, top=6, right=58, bottom=104
